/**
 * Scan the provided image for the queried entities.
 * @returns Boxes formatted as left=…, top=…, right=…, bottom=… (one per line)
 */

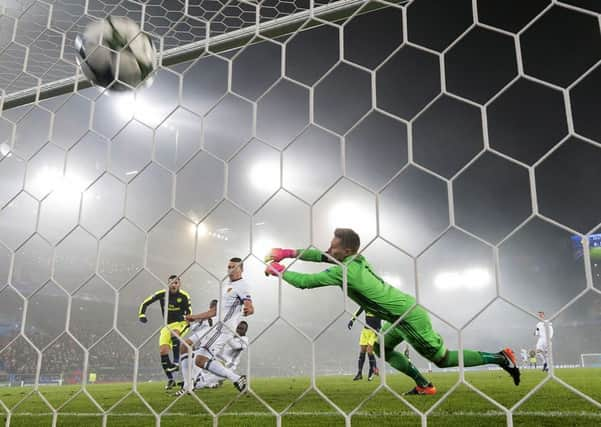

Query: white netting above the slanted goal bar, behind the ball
left=0, top=0, right=350, bottom=98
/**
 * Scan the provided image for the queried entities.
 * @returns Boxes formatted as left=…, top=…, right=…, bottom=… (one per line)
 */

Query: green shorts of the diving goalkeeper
left=382, top=306, right=447, bottom=362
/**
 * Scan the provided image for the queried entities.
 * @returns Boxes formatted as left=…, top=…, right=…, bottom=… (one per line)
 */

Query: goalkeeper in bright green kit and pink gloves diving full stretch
left=265, top=228, right=520, bottom=395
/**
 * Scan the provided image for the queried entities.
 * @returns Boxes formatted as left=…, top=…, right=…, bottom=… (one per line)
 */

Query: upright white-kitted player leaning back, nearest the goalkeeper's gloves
left=178, top=258, right=255, bottom=394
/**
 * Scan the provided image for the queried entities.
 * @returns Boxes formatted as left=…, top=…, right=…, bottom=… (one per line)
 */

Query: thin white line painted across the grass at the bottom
left=5, top=411, right=601, bottom=419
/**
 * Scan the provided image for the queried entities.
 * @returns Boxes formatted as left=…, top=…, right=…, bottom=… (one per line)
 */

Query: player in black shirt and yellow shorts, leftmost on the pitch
left=138, top=274, right=192, bottom=390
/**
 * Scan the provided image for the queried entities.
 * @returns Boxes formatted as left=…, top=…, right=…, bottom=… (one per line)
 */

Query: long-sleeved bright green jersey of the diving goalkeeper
left=282, top=249, right=415, bottom=323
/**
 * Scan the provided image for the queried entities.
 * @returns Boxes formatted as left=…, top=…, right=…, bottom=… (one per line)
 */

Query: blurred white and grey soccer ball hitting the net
left=75, top=16, right=157, bottom=90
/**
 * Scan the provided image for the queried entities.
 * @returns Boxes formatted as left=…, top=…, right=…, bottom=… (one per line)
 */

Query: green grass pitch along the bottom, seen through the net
left=0, top=368, right=601, bottom=427
